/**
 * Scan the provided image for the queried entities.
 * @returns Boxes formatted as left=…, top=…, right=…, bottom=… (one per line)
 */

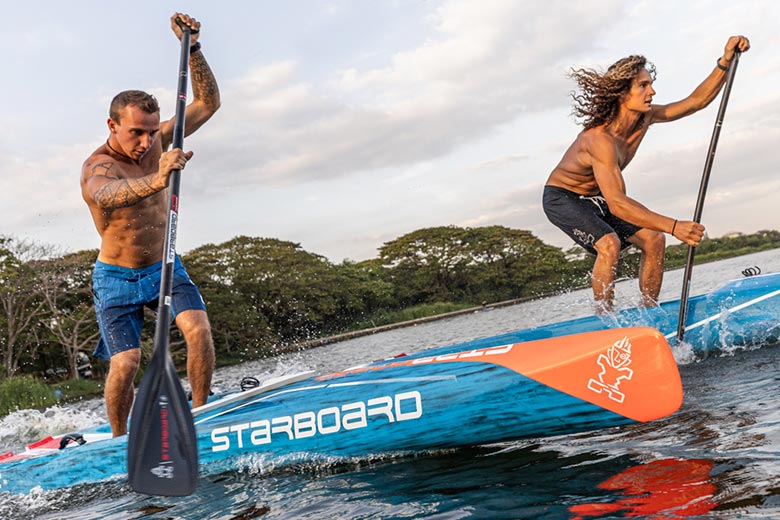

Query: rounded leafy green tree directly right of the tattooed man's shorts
left=185, top=236, right=374, bottom=354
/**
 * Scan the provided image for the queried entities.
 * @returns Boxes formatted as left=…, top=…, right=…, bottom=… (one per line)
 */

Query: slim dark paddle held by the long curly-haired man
left=677, top=49, right=740, bottom=343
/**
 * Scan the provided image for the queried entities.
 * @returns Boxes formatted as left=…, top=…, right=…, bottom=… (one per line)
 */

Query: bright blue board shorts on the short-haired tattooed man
left=92, top=255, right=206, bottom=359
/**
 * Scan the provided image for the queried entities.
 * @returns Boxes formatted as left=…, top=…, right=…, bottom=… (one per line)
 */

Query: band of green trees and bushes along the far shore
left=0, top=226, right=780, bottom=417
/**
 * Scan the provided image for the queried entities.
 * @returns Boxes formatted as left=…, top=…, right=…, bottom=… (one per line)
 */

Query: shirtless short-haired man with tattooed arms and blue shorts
left=81, top=13, right=220, bottom=436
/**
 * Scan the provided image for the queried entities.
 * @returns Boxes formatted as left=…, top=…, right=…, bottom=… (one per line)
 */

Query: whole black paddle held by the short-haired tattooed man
left=127, top=21, right=198, bottom=496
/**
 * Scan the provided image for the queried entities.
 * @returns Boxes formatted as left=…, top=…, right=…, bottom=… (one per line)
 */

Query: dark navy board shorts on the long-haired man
left=542, top=186, right=642, bottom=255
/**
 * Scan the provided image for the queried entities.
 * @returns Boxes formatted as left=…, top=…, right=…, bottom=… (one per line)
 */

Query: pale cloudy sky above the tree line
left=0, top=0, right=780, bottom=263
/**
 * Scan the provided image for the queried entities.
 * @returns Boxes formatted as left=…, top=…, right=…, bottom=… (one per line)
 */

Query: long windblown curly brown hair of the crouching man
left=568, top=55, right=655, bottom=130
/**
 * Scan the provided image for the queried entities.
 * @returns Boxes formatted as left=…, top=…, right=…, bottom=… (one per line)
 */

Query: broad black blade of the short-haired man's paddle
left=127, top=349, right=198, bottom=496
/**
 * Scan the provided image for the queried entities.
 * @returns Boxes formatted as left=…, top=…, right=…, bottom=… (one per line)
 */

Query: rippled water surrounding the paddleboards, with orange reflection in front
left=0, top=250, right=780, bottom=520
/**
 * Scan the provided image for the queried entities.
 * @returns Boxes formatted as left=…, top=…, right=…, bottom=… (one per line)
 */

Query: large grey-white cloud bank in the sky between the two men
left=192, top=1, right=621, bottom=188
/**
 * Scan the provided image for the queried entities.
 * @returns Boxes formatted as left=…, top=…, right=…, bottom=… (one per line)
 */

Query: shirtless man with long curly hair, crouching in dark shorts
left=543, top=36, right=750, bottom=311
